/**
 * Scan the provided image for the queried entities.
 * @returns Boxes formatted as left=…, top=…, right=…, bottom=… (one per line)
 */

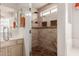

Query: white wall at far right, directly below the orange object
left=71, top=5, right=79, bottom=39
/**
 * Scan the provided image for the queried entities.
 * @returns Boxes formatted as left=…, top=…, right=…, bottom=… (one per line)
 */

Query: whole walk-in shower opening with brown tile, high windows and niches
left=31, top=3, right=57, bottom=56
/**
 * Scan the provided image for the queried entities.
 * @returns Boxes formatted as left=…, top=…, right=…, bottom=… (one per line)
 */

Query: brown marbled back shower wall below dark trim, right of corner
left=39, top=28, right=57, bottom=52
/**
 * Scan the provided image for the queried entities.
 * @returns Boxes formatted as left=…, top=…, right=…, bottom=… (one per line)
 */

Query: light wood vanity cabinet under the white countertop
left=0, top=39, right=23, bottom=56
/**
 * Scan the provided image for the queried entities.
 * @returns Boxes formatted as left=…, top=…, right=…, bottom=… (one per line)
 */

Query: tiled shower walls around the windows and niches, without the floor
left=32, top=4, right=58, bottom=51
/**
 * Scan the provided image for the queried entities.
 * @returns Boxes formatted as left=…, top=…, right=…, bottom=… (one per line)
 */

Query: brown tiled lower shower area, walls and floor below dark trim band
left=32, top=28, right=57, bottom=56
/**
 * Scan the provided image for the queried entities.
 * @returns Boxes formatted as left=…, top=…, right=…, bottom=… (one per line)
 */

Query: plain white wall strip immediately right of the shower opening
left=57, top=3, right=66, bottom=56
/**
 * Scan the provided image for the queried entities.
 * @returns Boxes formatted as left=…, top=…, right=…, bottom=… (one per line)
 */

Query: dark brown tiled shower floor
left=32, top=46, right=57, bottom=56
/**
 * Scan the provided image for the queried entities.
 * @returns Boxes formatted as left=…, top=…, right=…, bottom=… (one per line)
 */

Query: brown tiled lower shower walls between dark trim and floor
left=32, top=27, right=57, bottom=52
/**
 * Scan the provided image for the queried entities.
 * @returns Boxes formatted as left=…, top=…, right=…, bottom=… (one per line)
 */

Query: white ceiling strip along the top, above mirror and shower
left=1, top=3, right=47, bottom=9
